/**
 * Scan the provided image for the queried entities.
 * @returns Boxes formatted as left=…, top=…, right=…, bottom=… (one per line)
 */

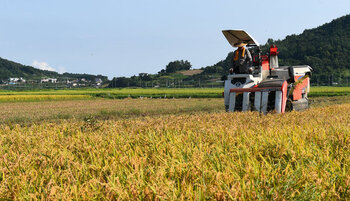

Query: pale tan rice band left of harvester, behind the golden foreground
left=0, top=98, right=224, bottom=124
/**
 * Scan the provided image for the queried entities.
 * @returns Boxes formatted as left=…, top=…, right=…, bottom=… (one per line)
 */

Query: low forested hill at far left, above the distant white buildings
left=0, top=58, right=107, bottom=81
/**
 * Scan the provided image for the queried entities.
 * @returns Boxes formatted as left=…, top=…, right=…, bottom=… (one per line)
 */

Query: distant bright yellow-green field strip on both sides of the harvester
left=0, top=87, right=350, bottom=102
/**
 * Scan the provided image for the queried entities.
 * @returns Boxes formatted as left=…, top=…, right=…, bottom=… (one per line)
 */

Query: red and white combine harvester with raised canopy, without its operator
left=222, top=30, right=312, bottom=114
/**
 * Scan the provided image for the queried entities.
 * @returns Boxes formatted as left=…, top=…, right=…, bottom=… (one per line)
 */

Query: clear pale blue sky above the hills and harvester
left=0, top=0, right=350, bottom=78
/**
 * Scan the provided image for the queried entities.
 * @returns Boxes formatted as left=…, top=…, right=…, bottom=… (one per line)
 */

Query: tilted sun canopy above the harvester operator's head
left=222, top=30, right=259, bottom=47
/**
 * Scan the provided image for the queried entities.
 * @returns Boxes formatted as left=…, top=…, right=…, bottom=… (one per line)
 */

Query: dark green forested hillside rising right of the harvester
left=263, top=15, right=350, bottom=76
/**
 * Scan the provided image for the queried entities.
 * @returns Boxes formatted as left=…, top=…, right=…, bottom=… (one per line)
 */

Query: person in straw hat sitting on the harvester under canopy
left=230, top=41, right=252, bottom=74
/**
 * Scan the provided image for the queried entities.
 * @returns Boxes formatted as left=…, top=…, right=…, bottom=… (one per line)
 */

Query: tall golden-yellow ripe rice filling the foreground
left=0, top=104, right=350, bottom=200
